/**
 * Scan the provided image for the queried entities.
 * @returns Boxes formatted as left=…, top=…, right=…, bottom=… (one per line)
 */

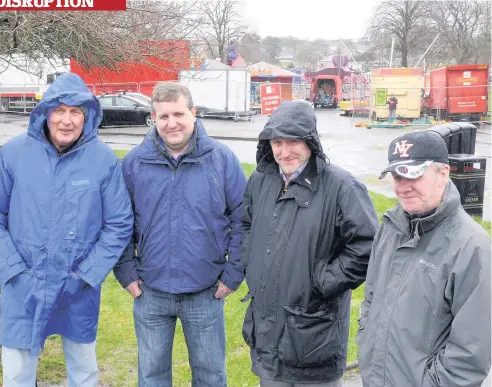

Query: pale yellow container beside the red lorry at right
left=371, top=68, right=424, bottom=119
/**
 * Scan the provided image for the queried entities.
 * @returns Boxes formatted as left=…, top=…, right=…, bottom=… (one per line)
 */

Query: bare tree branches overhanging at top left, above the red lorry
left=0, top=0, right=199, bottom=74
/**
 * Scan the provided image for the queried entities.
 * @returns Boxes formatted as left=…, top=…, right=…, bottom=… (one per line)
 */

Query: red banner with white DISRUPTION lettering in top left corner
left=0, top=0, right=126, bottom=12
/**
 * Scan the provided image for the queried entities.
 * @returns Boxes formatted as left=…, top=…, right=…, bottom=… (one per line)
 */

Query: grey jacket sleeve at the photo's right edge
left=422, top=237, right=491, bottom=387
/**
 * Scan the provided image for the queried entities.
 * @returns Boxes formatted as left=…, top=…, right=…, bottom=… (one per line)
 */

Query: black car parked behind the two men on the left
left=98, top=94, right=154, bottom=126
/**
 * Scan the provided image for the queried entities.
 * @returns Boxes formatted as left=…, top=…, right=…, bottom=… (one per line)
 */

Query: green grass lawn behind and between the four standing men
left=0, top=157, right=490, bottom=387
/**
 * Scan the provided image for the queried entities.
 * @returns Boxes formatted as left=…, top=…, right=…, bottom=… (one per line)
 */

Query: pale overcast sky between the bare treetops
left=238, top=0, right=378, bottom=40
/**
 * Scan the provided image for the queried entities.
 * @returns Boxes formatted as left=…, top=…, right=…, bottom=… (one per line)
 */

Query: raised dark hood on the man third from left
left=256, top=101, right=327, bottom=164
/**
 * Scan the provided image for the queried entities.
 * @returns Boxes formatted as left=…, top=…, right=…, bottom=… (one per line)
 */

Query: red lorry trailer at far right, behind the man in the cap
left=427, top=64, right=489, bottom=121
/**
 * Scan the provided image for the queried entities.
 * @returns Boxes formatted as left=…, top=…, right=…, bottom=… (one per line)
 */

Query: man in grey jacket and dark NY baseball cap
left=357, top=131, right=491, bottom=387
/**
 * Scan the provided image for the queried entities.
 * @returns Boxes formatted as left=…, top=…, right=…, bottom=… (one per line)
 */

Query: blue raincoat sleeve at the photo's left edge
left=0, top=149, right=27, bottom=285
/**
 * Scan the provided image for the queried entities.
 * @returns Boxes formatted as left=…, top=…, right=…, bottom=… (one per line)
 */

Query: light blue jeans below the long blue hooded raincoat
left=2, top=337, right=99, bottom=387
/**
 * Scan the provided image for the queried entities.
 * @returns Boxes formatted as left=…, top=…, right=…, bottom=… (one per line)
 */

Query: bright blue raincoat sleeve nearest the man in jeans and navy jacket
left=75, top=161, right=133, bottom=287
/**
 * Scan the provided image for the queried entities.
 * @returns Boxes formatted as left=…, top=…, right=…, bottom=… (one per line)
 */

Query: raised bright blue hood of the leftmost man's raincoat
left=27, top=73, right=103, bottom=143
